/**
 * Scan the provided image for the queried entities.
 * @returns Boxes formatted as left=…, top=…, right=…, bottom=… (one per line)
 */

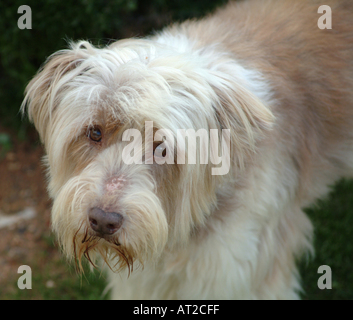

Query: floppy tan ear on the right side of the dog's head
left=209, top=68, right=275, bottom=167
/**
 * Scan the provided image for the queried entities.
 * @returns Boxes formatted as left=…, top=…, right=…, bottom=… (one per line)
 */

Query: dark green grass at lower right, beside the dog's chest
left=300, top=180, right=353, bottom=300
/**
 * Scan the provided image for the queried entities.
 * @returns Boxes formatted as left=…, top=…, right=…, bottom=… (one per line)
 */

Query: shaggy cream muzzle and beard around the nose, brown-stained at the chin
left=52, top=166, right=168, bottom=272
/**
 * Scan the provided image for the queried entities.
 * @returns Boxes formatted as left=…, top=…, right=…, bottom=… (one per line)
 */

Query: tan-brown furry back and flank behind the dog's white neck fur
left=158, top=0, right=353, bottom=206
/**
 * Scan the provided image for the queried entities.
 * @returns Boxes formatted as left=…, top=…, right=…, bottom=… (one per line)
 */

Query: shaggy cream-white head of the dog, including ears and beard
left=23, top=40, right=273, bottom=269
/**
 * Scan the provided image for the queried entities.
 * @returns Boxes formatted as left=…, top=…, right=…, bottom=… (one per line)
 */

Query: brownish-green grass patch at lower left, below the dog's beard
left=0, top=230, right=108, bottom=300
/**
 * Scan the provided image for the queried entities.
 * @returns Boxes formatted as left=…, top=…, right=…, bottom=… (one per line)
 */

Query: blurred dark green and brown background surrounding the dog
left=0, top=0, right=353, bottom=299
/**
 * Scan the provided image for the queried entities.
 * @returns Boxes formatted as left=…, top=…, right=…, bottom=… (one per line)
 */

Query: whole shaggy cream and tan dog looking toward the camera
left=21, top=0, right=353, bottom=299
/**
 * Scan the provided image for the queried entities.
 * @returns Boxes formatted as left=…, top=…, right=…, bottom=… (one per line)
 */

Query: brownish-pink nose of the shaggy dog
left=88, top=207, right=123, bottom=235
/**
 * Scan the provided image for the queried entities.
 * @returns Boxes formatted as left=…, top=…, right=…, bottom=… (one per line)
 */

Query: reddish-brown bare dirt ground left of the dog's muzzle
left=0, top=127, right=55, bottom=293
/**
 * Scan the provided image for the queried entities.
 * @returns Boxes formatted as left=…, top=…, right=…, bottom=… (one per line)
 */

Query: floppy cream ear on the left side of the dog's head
left=21, top=41, right=92, bottom=143
